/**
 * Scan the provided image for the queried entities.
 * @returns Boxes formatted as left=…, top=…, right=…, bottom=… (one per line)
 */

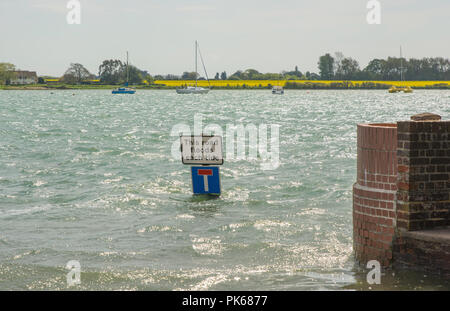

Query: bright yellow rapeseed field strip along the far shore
left=154, top=80, right=450, bottom=88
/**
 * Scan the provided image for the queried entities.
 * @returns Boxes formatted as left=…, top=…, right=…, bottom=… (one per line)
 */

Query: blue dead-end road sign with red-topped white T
left=191, top=166, right=220, bottom=195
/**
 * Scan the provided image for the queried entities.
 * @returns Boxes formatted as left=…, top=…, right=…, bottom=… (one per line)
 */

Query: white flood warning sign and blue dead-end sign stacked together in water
left=180, top=135, right=223, bottom=195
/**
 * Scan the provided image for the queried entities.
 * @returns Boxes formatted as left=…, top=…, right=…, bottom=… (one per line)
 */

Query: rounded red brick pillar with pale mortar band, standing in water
left=353, top=124, right=397, bottom=266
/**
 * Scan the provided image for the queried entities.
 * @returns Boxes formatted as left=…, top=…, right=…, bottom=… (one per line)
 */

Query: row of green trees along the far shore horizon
left=0, top=52, right=450, bottom=85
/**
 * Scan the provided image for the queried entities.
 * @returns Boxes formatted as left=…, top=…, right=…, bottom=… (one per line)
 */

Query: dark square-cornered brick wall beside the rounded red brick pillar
left=397, top=121, right=450, bottom=231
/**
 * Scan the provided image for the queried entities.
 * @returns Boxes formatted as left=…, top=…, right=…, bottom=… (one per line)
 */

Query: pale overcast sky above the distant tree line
left=0, top=0, right=450, bottom=77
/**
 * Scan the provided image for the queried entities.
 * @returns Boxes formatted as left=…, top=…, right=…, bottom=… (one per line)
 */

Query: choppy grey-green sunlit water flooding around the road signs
left=0, top=90, right=450, bottom=290
